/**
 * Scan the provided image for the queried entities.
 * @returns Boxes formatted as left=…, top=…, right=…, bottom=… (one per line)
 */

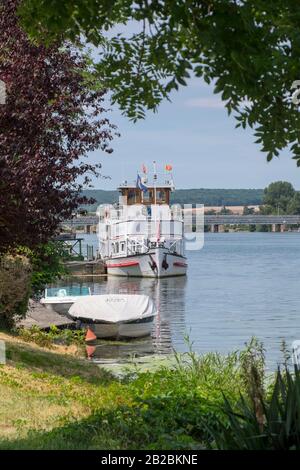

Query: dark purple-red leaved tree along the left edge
left=0, top=0, right=112, bottom=252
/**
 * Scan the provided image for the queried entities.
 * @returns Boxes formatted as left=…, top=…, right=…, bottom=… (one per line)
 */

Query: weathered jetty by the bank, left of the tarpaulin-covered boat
left=17, top=300, right=75, bottom=331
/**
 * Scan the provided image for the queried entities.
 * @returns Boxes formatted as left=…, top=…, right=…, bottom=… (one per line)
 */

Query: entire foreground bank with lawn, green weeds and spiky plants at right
left=0, top=333, right=300, bottom=450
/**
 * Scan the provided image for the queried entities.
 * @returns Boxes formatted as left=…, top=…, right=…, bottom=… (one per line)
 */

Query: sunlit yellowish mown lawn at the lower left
left=0, top=335, right=126, bottom=448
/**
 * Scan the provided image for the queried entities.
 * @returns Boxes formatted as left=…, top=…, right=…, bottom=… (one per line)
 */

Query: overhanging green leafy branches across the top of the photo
left=20, top=0, right=300, bottom=166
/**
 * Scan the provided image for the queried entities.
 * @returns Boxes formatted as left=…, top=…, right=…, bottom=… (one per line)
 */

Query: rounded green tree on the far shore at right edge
left=263, top=181, right=295, bottom=214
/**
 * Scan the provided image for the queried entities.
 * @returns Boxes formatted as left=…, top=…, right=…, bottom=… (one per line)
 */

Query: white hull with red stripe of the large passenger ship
left=106, top=247, right=187, bottom=278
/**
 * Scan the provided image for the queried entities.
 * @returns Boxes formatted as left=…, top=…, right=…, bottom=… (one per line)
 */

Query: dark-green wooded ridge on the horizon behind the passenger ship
left=83, top=188, right=263, bottom=212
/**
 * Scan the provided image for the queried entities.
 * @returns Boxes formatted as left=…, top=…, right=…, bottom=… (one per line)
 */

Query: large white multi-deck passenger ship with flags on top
left=98, top=165, right=187, bottom=278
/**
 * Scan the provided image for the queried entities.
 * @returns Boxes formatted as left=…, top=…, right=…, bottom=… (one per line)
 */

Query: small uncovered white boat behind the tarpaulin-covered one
left=40, top=286, right=91, bottom=315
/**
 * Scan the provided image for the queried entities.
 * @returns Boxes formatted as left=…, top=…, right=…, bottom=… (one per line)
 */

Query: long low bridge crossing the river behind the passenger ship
left=61, top=215, right=300, bottom=233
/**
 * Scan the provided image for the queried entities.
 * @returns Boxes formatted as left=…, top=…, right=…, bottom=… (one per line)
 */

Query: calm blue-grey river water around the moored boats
left=59, top=232, right=300, bottom=364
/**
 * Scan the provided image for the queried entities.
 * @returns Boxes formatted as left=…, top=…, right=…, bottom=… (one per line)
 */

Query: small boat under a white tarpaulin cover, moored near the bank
left=69, top=294, right=157, bottom=338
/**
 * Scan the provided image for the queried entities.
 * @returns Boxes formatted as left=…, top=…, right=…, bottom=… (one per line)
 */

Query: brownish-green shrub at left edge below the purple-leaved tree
left=0, top=255, right=31, bottom=329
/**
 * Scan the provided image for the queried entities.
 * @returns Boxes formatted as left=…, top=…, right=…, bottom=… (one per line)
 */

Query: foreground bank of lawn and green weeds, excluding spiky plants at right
left=0, top=334, right=251, bottom=449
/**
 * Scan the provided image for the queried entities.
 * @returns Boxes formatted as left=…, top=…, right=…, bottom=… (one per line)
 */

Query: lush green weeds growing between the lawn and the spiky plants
left=90, top=351, right=245, bottom=450
